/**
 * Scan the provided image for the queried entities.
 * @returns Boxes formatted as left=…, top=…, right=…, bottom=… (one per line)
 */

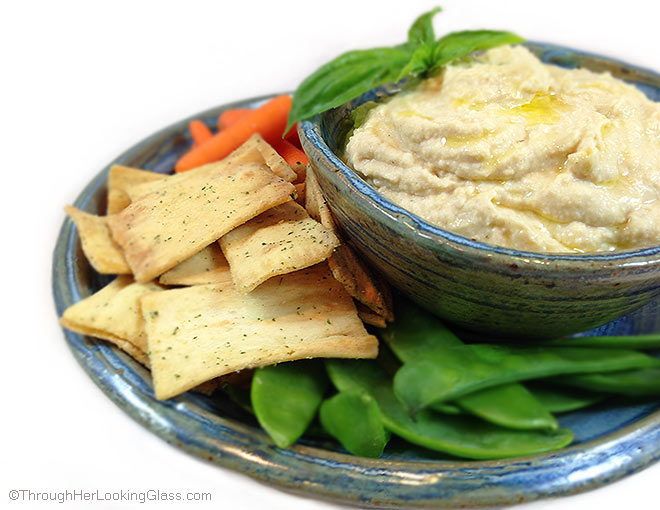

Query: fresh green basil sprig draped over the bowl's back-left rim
left=286, top=7, right=524, bottom=131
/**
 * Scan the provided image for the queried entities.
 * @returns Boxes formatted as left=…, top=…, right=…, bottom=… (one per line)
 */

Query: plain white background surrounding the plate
left=0, top=0, right=660, bottom=510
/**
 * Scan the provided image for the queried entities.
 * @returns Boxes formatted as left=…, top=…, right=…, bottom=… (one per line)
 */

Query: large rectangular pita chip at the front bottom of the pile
left=142, top=264, right=378, bottom=399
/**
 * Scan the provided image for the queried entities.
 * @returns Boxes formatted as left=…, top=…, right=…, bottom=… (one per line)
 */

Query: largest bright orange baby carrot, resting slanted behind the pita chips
left=175, top=95, right=291, bottom=172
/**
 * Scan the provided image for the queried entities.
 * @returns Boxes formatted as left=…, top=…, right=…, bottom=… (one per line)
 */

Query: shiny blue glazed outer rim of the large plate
left=52, top=77, right=660, bottom=508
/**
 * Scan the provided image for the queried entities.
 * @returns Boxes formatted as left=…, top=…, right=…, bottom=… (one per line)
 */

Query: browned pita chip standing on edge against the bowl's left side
left=305, top=168, right=394, bottom=324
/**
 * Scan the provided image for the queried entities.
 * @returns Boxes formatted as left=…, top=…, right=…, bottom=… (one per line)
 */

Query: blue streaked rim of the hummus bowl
left=298, top=41, right=660, bottom=271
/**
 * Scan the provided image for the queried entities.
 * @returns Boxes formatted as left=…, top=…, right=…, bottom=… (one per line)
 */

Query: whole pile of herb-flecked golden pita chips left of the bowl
left=61, top=131, right=391, bottom=398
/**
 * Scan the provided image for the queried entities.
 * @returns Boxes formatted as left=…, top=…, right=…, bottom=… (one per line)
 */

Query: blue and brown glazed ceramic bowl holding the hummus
left=299, top=43, right=660, bottom=338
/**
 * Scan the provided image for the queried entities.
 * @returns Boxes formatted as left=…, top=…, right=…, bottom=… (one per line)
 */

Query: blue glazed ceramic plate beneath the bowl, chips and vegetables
left=53, top=47, right=660, bottom=508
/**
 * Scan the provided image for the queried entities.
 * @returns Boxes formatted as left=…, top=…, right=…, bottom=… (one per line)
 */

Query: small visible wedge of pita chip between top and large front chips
left=159, top=244, right=232, bottom=285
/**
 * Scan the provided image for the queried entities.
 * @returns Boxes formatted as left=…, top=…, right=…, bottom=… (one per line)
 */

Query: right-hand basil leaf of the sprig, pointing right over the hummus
left=430, top=30, right=524, bottom=72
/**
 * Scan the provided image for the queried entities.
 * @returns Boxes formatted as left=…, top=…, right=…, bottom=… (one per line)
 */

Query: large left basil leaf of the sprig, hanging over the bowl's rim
left=285, top=45, right=411, bottom=132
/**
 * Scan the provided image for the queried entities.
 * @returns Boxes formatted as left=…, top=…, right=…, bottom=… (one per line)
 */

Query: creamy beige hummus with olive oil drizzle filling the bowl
left=345, top=46, right=660, bottom=253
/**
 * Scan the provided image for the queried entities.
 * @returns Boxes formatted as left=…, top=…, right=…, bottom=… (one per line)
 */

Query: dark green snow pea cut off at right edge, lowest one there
left=550, top=367, right=660, bottom=397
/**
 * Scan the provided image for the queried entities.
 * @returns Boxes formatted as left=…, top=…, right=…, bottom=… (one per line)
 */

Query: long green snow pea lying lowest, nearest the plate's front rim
left=326, top=360, right=573, bottom=459
